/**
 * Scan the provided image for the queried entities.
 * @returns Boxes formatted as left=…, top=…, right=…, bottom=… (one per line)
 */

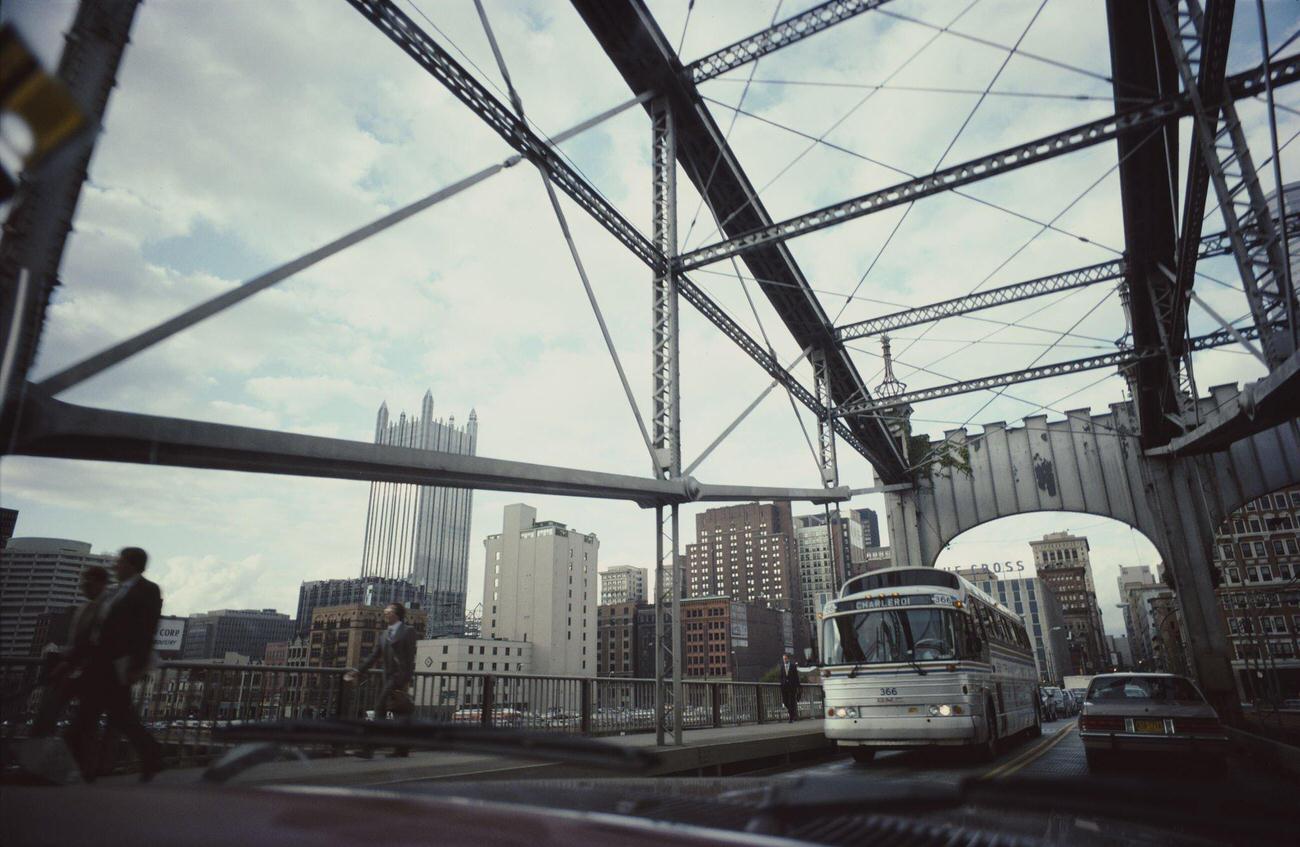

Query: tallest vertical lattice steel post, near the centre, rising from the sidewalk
left=650, top=90, right=683, bottom=744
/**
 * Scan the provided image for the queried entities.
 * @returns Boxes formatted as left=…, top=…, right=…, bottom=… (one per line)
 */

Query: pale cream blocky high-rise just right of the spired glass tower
left=482, top=503, right=601, bottom=677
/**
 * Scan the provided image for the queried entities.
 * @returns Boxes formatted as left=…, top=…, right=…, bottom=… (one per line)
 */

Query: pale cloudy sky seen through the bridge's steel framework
left=0, top=0, right=1300, bottom=633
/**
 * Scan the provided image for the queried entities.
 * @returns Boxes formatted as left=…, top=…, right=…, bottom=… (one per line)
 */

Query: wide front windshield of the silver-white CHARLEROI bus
left=826, top=609, right=958, bottom=665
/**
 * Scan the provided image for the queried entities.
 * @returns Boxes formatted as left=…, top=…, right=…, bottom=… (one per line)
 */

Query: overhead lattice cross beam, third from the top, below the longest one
left=835, top=213, right=1300, bottom=342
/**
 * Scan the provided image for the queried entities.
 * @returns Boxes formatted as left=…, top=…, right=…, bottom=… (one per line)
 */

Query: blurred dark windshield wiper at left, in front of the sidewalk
left=204, top=718, right=659, bottom=782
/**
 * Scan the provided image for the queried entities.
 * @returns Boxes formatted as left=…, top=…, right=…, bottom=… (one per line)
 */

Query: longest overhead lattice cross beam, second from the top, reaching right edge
left=679, top=55, right=1300, bottom=270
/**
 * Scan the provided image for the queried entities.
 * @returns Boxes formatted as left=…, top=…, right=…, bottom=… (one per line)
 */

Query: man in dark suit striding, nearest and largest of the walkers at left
left=68, top=547, right=163, bottom=782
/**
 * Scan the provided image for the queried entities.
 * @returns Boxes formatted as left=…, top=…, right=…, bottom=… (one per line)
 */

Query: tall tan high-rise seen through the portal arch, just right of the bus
left=1030, top=533, right=1106, bottom=673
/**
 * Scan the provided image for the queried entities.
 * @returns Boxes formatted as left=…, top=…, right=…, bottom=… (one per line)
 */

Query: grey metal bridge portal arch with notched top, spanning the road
left=885, top=386, right=1300, bottom=714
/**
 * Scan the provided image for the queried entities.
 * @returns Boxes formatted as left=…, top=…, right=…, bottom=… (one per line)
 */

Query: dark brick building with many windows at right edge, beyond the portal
left=1213, top=483, right=1300, bottom=703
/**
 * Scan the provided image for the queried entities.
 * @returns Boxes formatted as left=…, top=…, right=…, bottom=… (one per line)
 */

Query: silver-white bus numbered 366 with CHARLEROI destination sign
left=820, top=568, right=1041, bottom=761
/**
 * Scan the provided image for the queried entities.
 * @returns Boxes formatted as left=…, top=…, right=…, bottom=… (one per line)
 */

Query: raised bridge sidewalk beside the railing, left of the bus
left=100, top=720, right=831, bottom=786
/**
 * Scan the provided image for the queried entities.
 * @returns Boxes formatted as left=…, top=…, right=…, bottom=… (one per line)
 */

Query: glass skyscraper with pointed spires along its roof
left=361, top=391, right=478, bottom=634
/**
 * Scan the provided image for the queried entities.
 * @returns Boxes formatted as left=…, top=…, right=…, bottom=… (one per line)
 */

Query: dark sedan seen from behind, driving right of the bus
left=1079, top=673, right=1230, bottom=770
